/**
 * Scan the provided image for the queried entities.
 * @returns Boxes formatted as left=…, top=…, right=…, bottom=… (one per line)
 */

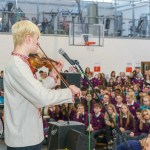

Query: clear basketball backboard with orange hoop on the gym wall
left=69, top=23, right=104, bottom=47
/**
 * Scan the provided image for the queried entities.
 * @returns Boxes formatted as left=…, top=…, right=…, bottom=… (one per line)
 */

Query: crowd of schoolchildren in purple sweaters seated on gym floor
left=0, top=67, right=150, bottom=149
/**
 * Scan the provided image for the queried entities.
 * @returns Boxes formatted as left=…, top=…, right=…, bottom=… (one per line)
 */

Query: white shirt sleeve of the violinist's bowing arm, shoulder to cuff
left=5, top=59, right=73, bottom=108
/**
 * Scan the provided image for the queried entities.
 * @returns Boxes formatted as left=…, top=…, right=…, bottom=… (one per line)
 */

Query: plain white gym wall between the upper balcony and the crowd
left=0, top=34, right=150, bottom=77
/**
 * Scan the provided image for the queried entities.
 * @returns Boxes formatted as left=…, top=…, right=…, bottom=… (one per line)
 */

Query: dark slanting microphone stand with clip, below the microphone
left=72, top=60, right=131, bottom=150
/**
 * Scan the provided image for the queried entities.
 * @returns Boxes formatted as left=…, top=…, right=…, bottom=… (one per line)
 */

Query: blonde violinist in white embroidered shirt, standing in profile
left=4, top=20, right=80, bottom=150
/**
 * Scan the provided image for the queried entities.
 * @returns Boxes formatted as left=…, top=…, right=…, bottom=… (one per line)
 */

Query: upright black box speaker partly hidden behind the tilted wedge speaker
left=48, top=121, right=85, bottom=150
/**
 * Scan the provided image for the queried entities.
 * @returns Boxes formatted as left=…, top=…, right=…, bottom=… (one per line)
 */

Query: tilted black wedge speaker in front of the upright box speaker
left=66, top=129, right=96, bottom=150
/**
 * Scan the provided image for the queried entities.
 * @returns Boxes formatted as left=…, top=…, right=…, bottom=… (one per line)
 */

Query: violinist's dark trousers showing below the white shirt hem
left=7, top=143, right=42, bottom=150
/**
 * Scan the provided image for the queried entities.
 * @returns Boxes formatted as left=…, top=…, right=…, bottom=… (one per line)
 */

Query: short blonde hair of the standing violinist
left=12, top=20, right=40, bottom=47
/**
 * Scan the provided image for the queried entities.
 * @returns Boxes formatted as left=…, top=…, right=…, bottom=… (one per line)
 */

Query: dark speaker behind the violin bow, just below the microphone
left=61, top=73, right=81, bottom=88
